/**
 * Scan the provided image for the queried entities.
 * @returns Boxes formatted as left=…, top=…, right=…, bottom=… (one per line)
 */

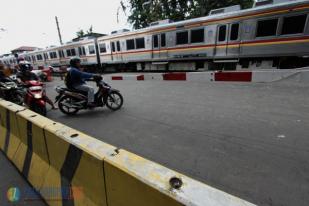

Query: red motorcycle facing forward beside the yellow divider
left=24, top=80, right=47, bottom=116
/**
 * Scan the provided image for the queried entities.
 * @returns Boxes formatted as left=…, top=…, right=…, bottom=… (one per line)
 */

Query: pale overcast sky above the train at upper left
left=0, top=0, right=127, bottom=54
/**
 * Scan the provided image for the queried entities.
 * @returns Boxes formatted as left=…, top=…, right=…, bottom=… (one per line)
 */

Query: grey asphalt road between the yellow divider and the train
left=0, top=77, right=309, bottom=206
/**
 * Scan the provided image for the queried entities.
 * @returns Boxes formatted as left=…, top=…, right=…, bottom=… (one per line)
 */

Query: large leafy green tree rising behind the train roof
left=121, top=0, right=253, bottom=29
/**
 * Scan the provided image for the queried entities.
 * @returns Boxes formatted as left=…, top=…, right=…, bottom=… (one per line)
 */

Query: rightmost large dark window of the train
left=281, top=14, right=307, bottom=35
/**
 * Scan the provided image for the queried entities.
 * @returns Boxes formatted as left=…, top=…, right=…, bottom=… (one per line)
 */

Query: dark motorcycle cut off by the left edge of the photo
left=0, top=77, right=24, bottom=105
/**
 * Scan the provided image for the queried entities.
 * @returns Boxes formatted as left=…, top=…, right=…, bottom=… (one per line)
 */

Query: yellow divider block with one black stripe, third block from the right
left=13, top=110, right=53, bottom=193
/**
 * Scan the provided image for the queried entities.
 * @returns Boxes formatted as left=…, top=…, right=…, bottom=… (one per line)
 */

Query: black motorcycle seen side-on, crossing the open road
left=55, top=78, right=123, bottom=115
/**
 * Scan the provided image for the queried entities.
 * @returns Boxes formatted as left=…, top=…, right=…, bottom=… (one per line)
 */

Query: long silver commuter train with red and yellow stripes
left=0, top=0, right=309, bottom=72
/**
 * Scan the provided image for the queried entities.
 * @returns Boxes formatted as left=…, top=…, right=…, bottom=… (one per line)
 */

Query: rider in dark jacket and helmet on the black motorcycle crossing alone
left=65, top=57, right=101, bottom=107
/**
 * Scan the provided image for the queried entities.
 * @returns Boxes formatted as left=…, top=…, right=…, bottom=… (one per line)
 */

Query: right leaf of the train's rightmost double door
left=227, top=23, right=241, bottom=58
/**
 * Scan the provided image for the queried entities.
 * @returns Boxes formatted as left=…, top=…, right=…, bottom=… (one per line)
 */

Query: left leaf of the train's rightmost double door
left=215, top=24, right=228, bottom=57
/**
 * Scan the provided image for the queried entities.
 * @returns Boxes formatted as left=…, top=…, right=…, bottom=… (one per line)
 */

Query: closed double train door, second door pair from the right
left=152, top=33, right=168, bottom=59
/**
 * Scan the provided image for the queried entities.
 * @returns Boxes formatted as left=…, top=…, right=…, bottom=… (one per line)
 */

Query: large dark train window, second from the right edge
left=256, top=19, right=278, bottom=37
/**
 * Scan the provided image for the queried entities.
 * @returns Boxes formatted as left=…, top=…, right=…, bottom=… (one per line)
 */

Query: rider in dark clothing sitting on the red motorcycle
left=16, top=61, right=57, bottom=109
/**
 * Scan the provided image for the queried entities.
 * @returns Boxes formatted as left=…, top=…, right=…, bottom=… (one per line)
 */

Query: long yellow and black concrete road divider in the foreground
left=0, top=98, right=253, bottom=206
